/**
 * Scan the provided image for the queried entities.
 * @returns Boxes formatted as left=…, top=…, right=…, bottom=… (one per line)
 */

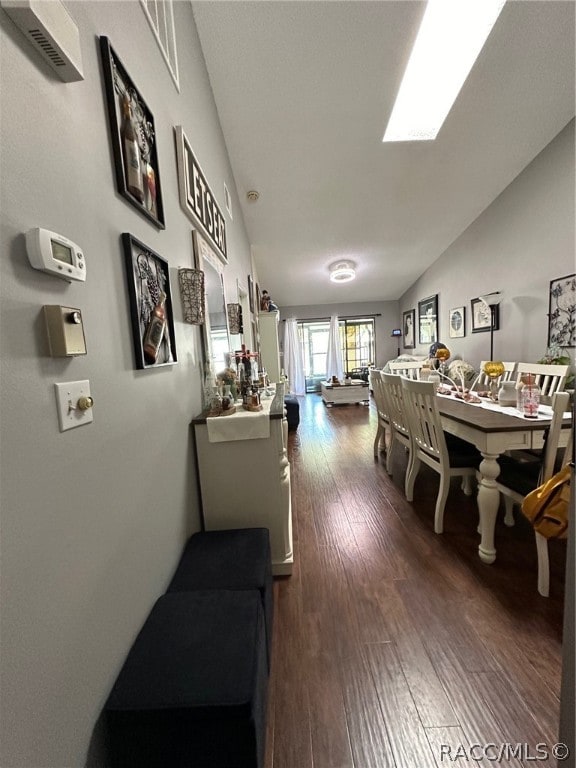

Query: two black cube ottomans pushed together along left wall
left=104, top=528, right=274, bottom=768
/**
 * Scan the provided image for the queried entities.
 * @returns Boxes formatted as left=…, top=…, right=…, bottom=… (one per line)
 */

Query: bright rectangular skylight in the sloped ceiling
left=383, top=0, right=505, bottom=141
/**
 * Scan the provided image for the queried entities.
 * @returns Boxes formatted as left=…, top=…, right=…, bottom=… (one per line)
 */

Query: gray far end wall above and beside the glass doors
left=280, top=300, right=400, bottom=367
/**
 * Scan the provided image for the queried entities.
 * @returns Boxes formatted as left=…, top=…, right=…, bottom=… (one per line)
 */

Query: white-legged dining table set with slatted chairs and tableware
left=370, top=356, right=574, bottom=597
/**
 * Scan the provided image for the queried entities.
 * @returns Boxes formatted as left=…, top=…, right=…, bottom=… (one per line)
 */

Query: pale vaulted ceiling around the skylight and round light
left=192, top=0, right=575, bottom=306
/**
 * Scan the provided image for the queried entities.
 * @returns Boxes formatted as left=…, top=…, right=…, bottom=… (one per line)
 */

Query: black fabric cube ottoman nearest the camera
left=105, top=590, right=267, bottom=768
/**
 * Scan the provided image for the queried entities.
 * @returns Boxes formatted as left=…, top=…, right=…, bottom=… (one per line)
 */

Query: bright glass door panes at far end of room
left=298, top=318, right=375, bottom=392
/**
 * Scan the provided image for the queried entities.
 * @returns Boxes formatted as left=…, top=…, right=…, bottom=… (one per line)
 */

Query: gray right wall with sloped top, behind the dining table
left=400, top=120, right=576, bottom=365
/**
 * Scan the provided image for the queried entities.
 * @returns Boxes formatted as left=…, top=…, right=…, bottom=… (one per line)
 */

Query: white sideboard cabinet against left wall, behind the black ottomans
left=192, top=384, right=293, bottom=575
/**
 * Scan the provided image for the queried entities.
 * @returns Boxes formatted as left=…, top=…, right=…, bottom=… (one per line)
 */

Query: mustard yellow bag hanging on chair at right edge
left=522, top=464, right=572, bottom=539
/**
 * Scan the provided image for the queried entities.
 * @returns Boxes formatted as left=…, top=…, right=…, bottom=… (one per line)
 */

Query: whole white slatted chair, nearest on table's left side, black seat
left=402, top=379, right=482, bottom=533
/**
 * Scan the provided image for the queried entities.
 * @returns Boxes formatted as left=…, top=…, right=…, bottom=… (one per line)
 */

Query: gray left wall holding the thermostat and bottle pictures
left=0, top=0, right=250, bottom=768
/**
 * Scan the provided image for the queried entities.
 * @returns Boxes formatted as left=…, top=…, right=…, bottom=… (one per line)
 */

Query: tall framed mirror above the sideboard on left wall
left=192, top=230, right=230, bottom=374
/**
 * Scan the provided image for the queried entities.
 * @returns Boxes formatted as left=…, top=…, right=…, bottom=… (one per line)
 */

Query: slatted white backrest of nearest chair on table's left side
left=402, top=379, right=448, bottom=464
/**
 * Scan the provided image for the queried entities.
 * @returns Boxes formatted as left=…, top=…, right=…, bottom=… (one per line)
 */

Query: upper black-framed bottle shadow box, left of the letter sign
left=99, top=36, right=166, bottom=229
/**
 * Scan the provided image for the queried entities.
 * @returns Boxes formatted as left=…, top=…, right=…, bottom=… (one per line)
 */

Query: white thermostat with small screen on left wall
left=26, top=227, right=86, bottom=282
